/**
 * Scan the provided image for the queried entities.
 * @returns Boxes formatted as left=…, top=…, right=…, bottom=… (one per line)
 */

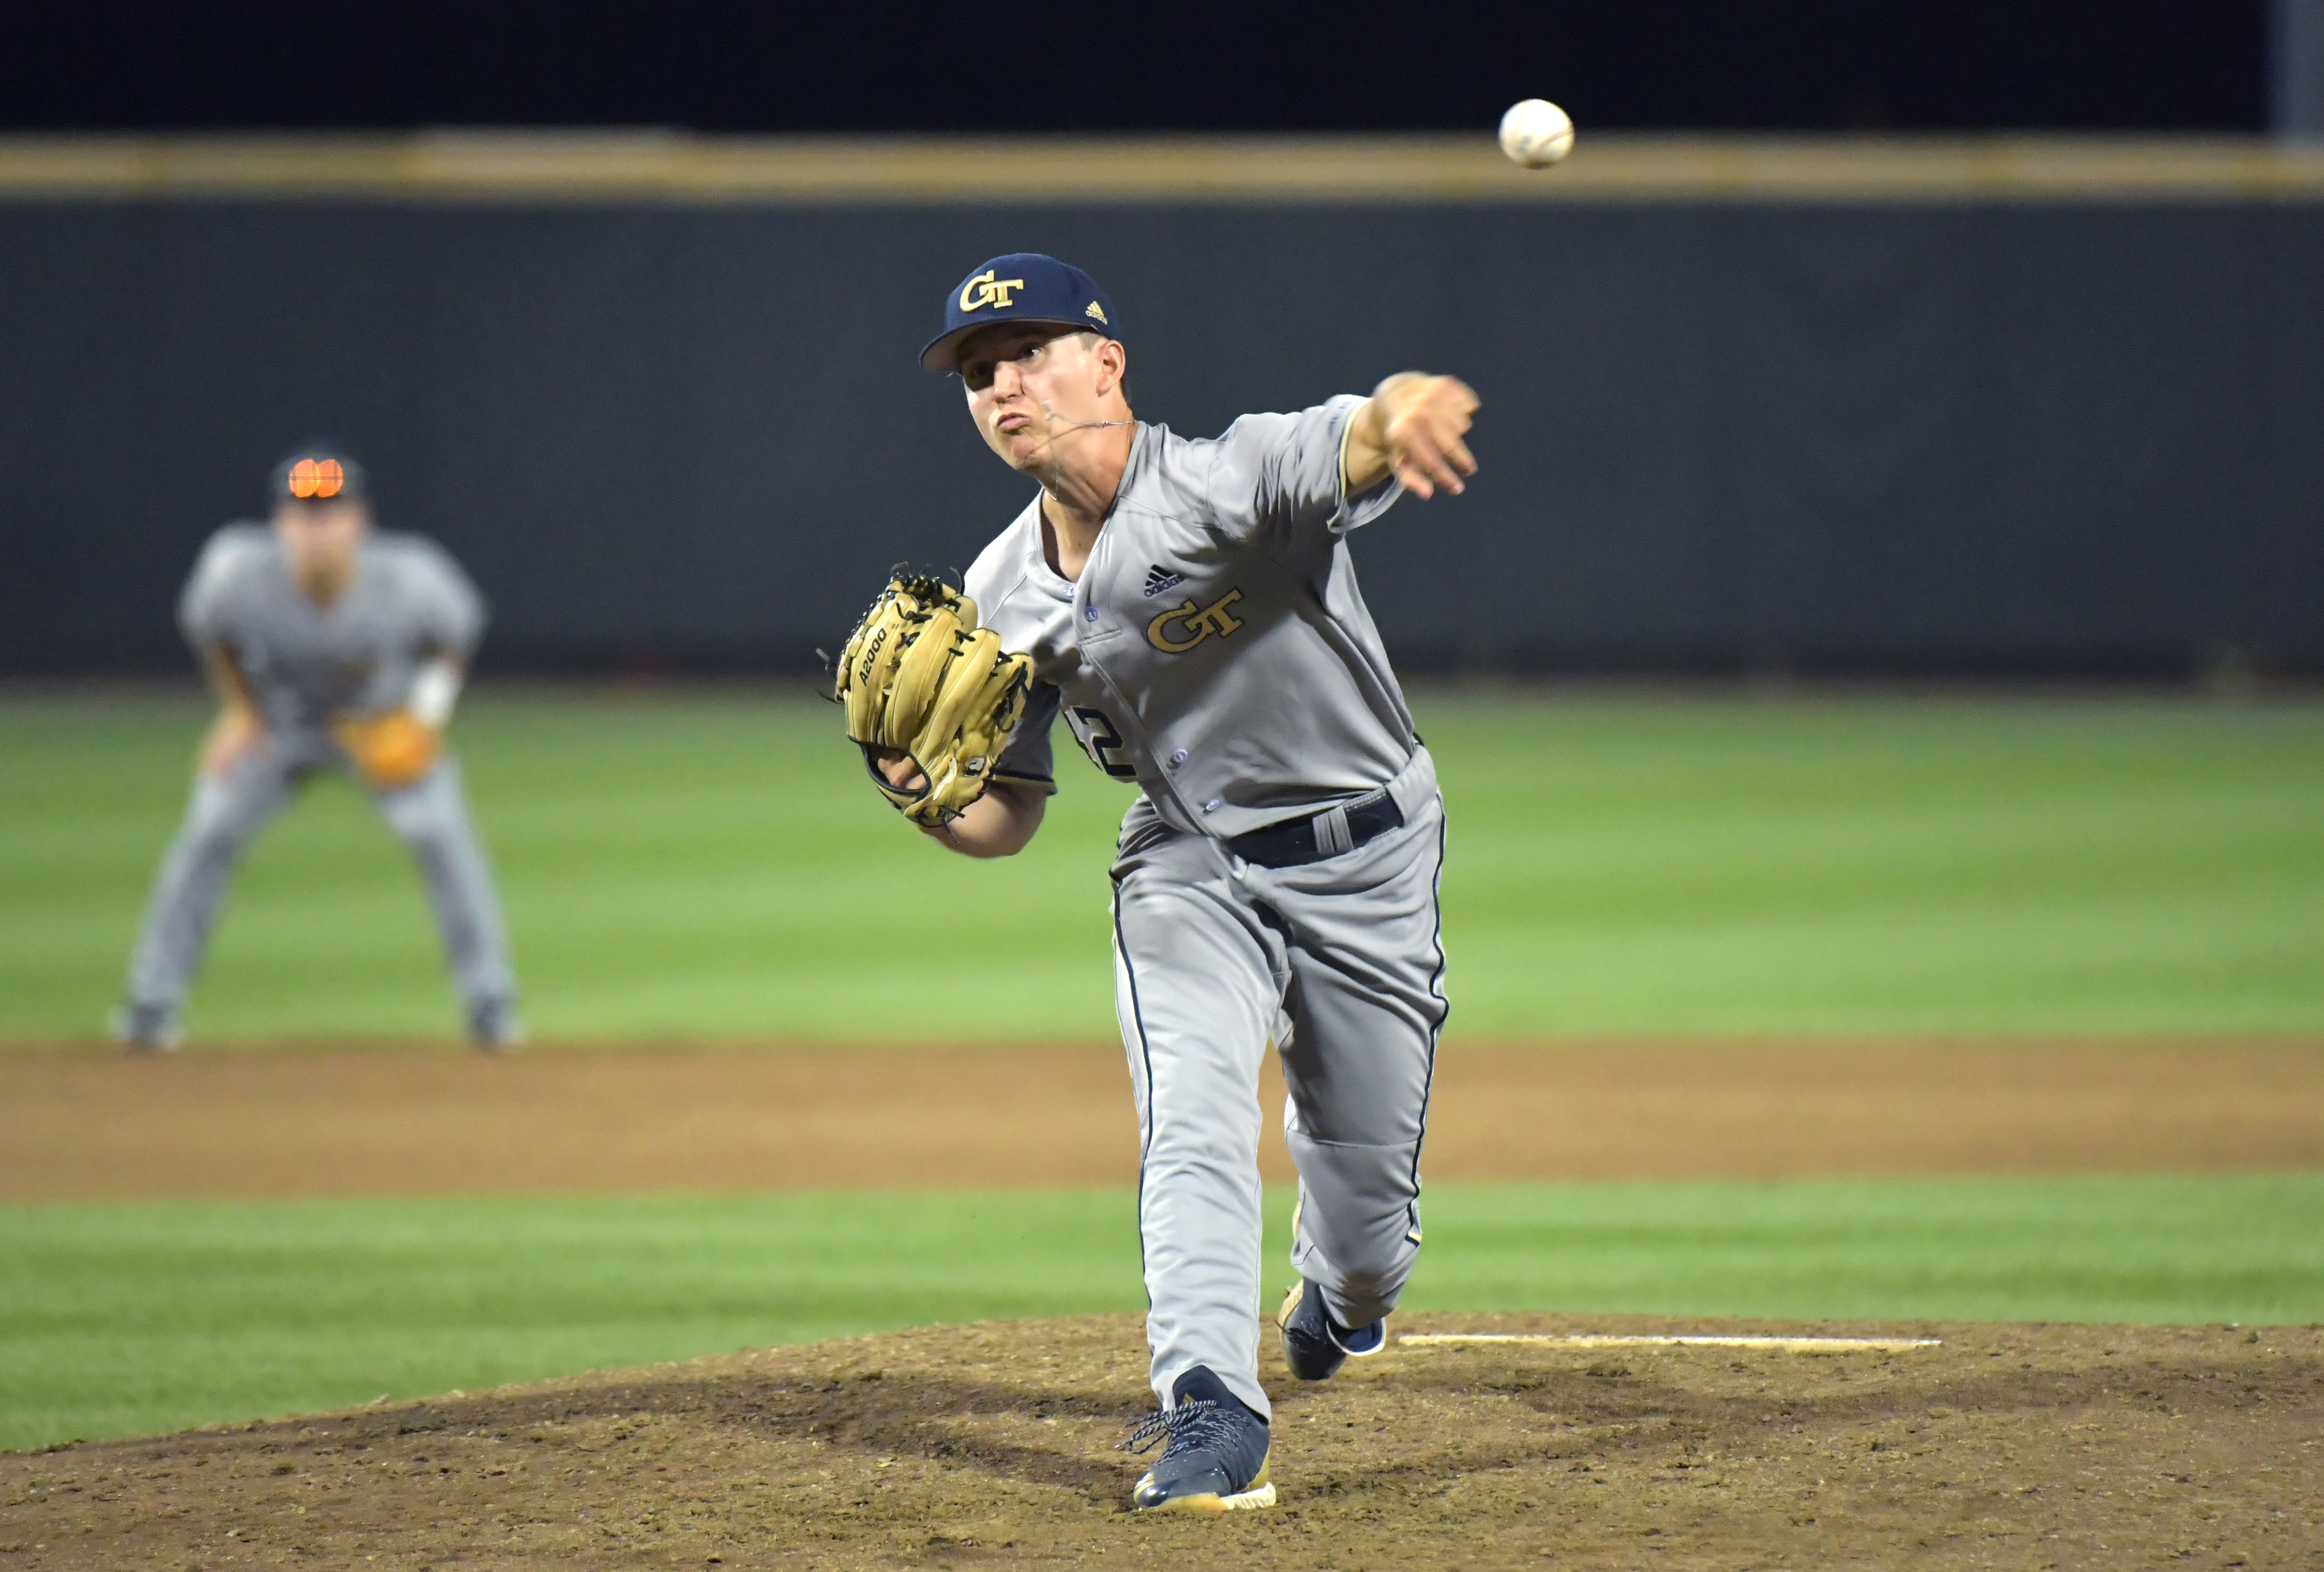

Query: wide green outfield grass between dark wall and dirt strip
left=13, top=691, right=2324, bottom=1042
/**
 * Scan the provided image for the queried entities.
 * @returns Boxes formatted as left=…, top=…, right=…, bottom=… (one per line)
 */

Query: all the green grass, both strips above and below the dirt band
left=0, top=688, right=2324, bottom=1446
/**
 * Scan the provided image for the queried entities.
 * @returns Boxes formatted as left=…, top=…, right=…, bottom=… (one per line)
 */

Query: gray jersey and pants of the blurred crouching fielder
left=128, top=523, right=516, bottom=1021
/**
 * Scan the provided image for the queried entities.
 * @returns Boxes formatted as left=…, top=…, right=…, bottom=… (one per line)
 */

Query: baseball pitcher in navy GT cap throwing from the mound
left=837, top=254, right=1476, bottom=1512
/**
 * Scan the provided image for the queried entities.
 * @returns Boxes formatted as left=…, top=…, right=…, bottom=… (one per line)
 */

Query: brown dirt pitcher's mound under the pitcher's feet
left=0, top=1316, right=2324, bottom=1572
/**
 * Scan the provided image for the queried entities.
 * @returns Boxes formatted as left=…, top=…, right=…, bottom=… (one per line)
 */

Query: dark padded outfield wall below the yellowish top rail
left=0, top=202, right=2324, bottom=672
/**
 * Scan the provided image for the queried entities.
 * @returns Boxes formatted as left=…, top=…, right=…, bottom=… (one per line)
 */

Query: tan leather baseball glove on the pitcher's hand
left=832, top=577, right=1032, bottom=830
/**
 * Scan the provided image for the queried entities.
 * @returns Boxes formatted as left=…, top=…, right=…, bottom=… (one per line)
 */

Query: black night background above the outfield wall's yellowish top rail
left=0, top=0, right=2266, bottom=133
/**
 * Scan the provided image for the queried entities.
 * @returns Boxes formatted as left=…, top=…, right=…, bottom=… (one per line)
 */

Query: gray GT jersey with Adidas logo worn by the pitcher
left=965, top=398, right=1416, bottom=837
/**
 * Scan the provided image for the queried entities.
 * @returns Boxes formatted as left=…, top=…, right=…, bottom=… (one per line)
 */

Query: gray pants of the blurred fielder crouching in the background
left=128, top=735, right=516, bottom=1012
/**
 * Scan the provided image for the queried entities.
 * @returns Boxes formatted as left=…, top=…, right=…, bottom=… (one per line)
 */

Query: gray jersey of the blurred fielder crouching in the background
left=179, top=523, right=483, bottom=732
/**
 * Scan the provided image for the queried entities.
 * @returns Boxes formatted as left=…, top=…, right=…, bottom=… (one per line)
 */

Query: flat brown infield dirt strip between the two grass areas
left=0, top=1042, right=2324, bottom=1200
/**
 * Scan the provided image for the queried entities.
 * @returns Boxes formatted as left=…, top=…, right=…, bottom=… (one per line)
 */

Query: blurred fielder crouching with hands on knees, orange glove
left=116, top=446, right=523, bottom=1049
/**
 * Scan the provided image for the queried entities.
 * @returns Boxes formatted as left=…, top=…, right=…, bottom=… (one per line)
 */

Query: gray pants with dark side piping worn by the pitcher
left=1113, top=751, right=1446, bottom=1414
